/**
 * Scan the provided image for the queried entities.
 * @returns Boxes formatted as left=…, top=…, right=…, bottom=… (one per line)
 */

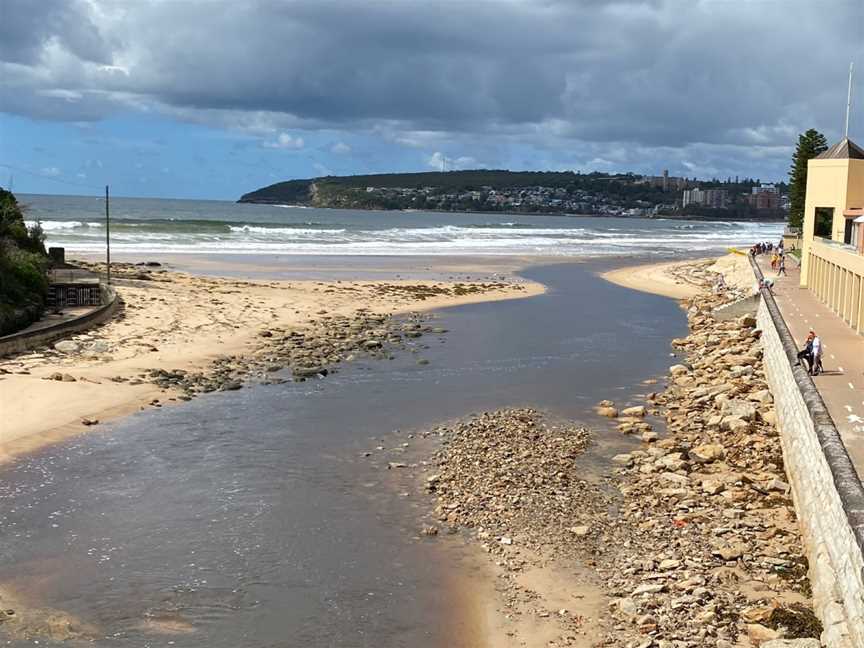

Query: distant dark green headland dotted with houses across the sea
left=238, top=169, right=788, bottom=221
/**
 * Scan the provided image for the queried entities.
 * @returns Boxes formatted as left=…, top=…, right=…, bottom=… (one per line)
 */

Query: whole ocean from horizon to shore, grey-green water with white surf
left=20, top=194, right=782, bottom=256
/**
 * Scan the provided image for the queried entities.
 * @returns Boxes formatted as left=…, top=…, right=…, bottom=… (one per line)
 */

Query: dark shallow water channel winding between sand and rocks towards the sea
left=0, top=263, right=686, bottom=648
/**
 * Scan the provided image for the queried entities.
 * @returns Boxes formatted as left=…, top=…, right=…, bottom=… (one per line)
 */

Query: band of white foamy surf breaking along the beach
left=42, top=213, right=782, bottom=256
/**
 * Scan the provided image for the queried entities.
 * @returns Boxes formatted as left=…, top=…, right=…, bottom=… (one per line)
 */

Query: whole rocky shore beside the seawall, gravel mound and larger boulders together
left=422, top=263, right=821, bottom=648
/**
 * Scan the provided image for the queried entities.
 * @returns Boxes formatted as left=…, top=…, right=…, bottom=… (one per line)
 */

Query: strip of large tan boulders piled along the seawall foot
left=598, top=266, right=821, bottom=648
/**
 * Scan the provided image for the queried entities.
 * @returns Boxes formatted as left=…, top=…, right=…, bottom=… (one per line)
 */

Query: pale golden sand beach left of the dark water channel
left=0, top=266, right=544, bottom=461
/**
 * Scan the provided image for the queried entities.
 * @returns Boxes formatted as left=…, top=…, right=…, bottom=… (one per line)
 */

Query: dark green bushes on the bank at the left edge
left=0, top=188, right=48, bottom=335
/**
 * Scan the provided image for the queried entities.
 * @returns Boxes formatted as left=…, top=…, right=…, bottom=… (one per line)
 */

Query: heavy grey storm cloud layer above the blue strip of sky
left=0, top=0, right=864, bottom=154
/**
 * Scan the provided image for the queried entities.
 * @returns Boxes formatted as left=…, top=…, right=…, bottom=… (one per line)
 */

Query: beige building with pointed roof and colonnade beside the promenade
left=801, top=139, right=864, bottom=333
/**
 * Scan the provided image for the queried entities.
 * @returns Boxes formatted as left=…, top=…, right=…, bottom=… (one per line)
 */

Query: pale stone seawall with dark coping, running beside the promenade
left=751, top=261, right=864, bottom=648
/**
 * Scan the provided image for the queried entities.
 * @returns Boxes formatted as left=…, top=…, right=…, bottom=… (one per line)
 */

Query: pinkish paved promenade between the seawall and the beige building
left=759, top=256, right=864, bottom=477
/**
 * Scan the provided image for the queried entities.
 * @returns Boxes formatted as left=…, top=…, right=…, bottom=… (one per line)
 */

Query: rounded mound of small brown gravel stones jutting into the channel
left=427, top=408, right=603, bottom=551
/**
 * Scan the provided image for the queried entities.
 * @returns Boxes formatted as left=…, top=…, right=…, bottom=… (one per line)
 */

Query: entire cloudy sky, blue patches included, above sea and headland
left=0, top=0, right=864, bottom=199
